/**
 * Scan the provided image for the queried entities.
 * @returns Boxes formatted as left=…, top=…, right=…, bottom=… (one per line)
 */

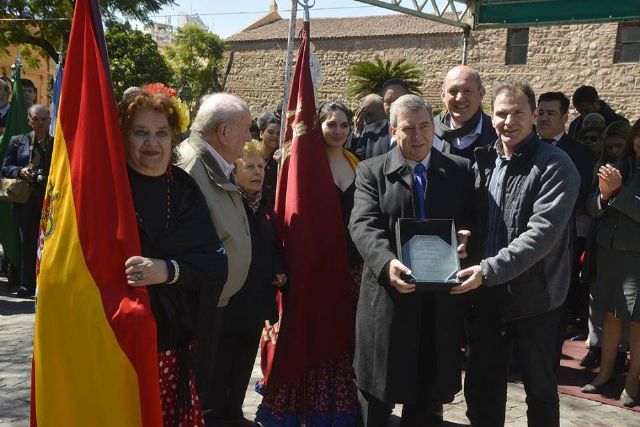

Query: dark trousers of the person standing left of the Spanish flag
left=13, top=200, right=42, bottom=291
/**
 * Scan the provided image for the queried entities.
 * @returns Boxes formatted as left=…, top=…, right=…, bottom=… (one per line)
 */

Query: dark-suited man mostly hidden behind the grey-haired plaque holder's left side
left=347, top=78, right=411, bottom=160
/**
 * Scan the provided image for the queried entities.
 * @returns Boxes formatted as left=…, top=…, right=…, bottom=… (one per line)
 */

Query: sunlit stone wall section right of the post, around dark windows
left=469, top=24, right=640, bottom=121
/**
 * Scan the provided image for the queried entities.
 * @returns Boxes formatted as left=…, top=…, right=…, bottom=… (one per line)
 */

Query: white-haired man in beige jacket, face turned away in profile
left=178, top=93, right=251, bottom=419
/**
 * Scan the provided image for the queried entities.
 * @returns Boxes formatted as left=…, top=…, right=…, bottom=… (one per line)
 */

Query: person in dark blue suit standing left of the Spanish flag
left=2, top=104, right=53, bottom=297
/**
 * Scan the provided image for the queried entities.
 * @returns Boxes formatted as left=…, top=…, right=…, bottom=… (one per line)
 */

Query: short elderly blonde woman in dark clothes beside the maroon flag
left=211, top=140, right=287, bottom=426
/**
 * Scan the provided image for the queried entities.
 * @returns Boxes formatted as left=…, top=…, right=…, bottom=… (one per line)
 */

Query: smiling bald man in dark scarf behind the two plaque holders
left=435, top=65, right=498, bottom=162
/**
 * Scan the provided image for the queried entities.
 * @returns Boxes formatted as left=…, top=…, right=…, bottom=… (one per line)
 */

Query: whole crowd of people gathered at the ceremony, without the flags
left=0, top=66, right=640, bottom=427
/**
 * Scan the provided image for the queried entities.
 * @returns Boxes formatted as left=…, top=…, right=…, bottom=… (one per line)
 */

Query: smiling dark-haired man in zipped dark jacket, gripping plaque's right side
left=451, top=82, right=580, bottom=427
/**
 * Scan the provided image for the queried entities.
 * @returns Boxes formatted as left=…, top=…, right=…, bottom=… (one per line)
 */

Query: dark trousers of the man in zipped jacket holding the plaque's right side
left=464, top=299, right=560, bottom=427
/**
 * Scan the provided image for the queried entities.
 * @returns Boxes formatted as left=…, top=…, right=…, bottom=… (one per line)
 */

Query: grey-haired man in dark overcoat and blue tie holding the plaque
left=350, top=95, right=473, bottom=427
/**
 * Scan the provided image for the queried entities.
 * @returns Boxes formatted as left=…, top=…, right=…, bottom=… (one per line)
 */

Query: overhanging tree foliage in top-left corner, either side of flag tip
left=0, top=0, right=174, bottom=63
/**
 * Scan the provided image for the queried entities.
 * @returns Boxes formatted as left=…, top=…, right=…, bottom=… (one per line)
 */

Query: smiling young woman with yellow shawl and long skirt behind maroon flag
left=256, top=101, right=362, bottom=427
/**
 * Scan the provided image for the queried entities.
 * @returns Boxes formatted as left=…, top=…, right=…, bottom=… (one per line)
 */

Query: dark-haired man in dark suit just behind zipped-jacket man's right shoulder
left=536, top=92, right=595, bottom=364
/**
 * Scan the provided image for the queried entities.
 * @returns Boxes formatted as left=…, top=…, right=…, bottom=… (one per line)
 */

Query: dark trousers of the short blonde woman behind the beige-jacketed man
left=210, top=327, right=262, bottom=421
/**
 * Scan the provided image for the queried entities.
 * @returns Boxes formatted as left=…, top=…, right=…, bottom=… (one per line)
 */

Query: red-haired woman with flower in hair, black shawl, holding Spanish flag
left=119, top=85, right=227, bottom=426
